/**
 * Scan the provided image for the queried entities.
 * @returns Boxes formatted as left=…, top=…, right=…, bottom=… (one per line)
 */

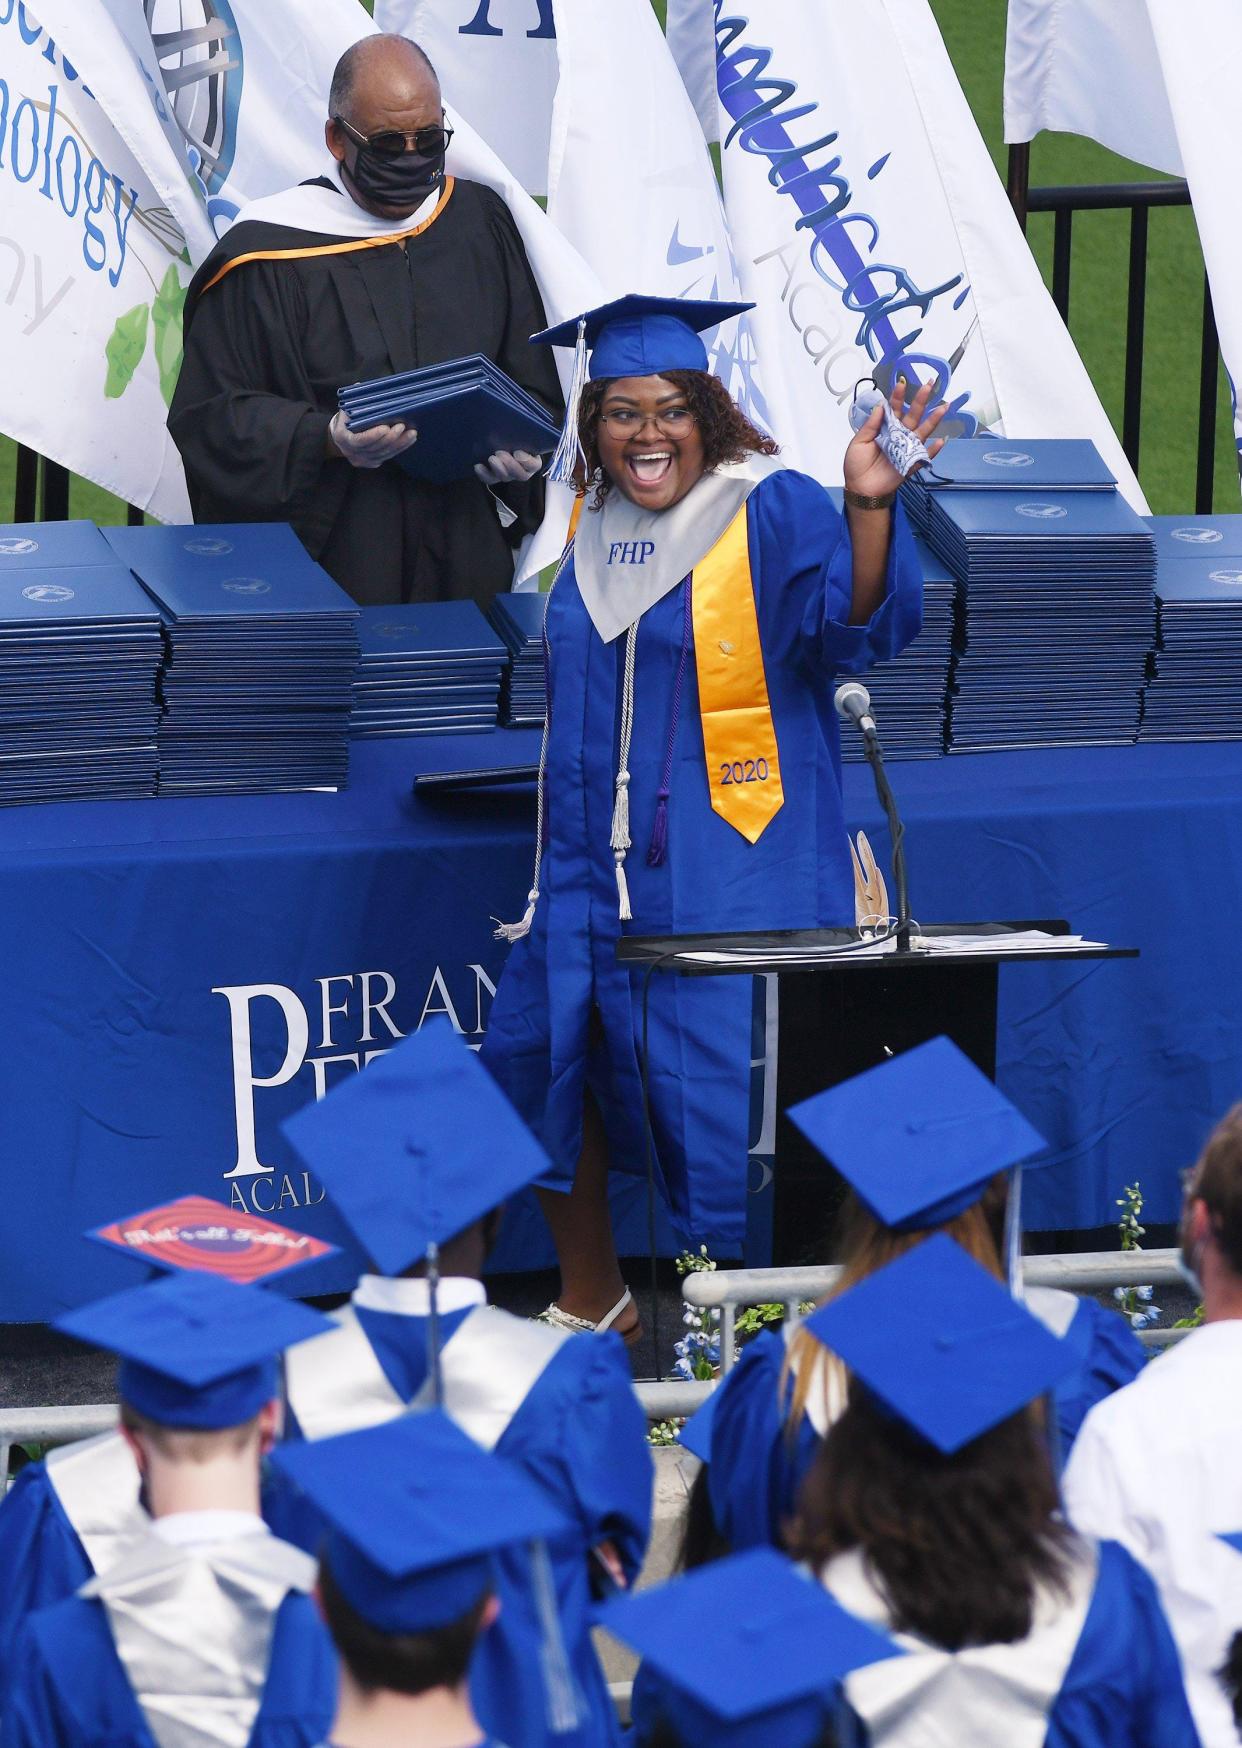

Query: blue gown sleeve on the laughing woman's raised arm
left=749, top=470, right=922, bottom=673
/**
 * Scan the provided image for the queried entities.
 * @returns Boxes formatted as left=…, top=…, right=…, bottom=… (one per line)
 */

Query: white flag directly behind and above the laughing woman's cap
left=549, top=0, right=769, bottom=425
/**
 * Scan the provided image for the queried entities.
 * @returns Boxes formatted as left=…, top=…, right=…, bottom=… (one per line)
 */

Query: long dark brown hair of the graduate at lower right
left=790, top=1388, right=1074, bottom=1650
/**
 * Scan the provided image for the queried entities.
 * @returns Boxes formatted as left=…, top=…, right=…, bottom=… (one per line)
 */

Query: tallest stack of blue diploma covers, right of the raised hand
left=907, top=439, right=1155, bottom=752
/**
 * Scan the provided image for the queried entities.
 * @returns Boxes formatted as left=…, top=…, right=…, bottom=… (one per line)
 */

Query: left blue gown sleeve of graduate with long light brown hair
left=707, top=1332, right=819, bottom=1554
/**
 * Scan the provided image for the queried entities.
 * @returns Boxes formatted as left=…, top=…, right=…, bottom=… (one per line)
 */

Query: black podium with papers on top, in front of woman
left=617, top=919, right=1137, bottom=1264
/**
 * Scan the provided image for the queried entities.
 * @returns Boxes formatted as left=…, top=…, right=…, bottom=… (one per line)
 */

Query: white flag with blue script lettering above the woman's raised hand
left=684, top=0, right=1146, bottom=509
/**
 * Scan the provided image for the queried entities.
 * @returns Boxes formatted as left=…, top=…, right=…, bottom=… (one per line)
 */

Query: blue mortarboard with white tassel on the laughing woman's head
left=531, top=292, right=755, bottom=484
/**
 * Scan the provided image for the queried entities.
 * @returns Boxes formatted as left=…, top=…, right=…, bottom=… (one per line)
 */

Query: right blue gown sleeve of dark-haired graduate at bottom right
left=1045, top=1542, right=1200, bottom=1748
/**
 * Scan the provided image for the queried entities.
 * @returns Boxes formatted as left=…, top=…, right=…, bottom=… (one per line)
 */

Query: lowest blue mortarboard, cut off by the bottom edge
left=596, top=1547, right=901, bottom=1748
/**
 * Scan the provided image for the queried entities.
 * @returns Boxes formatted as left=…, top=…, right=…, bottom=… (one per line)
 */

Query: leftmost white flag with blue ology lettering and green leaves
left=0, top=5, right=192, bottom=521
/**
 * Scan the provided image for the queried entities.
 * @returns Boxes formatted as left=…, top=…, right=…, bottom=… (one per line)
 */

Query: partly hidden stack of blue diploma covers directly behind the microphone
left=840, top=537, right=957, bottom=760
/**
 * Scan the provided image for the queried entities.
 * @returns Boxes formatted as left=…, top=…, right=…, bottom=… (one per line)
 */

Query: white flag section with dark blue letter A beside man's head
left=376, top=0, right=558, bottom=194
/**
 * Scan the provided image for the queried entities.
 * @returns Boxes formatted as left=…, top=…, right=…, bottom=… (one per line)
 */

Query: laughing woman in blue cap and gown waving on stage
left=484, top=297, right=938, bottom=1334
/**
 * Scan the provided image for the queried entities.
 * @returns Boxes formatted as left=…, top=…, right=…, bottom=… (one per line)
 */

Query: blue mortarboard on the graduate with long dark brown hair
left=804, top=1232, right=1078, bottom=1456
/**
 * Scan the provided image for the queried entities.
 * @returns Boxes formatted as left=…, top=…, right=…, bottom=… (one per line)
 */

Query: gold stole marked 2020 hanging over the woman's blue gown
left=690, top=505, right=784, bottom=844
